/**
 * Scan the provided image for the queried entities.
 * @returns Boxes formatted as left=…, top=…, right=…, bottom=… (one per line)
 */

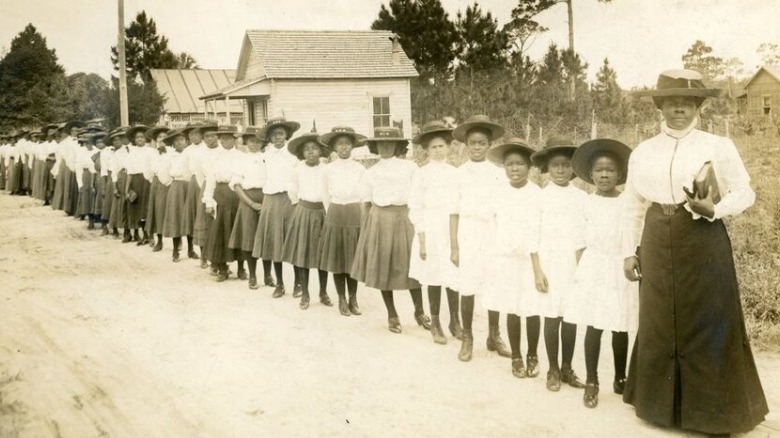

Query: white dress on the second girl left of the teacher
left=527, top=182, right=587, bottom=318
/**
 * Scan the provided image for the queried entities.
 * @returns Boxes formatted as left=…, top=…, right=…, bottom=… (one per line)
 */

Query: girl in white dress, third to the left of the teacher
left=488, top=138, right=541, bottom=378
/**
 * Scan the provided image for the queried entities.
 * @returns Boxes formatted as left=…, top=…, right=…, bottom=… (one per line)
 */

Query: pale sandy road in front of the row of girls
left=0, top=194, right=780, bottom=437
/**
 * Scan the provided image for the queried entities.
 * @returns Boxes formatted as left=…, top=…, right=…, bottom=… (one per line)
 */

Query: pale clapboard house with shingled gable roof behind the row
left=201, top=30, right=418, bottom=143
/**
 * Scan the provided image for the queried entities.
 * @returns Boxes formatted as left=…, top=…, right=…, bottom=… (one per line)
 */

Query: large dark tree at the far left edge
left=0, top=24, right=66, bottom=127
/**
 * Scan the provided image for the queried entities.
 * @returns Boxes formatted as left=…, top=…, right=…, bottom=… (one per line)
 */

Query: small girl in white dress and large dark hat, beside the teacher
left=564, top=139, right=639, bottom=408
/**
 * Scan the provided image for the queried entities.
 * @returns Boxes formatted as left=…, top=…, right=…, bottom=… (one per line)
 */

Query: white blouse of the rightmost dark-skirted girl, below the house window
left=360, top=157, right=418, bottom=207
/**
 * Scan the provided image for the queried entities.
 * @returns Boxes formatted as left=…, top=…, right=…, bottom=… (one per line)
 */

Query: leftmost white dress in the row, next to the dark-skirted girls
left=409, top=161, right=458, bottom=289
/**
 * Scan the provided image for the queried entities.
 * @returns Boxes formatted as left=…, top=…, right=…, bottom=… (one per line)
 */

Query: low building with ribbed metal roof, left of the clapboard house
left=151, top=69, right=243, bottom=128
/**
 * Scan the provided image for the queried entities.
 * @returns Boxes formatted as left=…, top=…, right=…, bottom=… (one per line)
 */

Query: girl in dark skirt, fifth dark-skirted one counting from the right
left=229, top=126, right=273, bottom=290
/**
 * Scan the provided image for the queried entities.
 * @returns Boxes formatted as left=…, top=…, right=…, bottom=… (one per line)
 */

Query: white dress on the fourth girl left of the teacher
left=455, top=160, right=506, bottom=296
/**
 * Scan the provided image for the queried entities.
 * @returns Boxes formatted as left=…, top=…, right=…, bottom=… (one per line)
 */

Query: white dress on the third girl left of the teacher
left=480, top=181, right=542, bottom=316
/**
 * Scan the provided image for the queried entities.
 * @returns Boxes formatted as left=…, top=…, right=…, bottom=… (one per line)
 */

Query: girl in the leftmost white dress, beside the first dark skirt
left=409, top=120, right=463, bottom=344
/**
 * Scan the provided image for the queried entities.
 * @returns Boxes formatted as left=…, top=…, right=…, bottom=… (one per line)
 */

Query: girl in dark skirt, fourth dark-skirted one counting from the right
left=252, top=117, right=303, bottom=298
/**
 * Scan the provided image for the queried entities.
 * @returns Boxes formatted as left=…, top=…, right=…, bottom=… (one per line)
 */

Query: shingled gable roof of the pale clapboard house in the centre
left=246, top=30, right=418, bottom=79
